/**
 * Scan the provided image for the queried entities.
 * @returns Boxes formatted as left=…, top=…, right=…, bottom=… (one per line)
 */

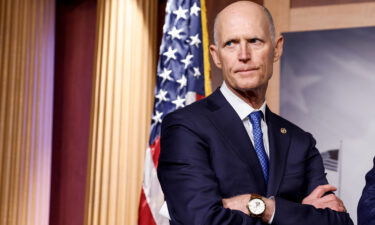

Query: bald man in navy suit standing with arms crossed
left=158, top=1, right=353, bottom=225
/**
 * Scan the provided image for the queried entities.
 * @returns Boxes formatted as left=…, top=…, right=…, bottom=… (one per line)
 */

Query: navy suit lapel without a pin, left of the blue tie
left=208, top=89, right=266, bottom=192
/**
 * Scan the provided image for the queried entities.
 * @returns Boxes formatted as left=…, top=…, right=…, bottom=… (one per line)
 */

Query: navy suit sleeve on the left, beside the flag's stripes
left=158, top=113, right=258, bottom=225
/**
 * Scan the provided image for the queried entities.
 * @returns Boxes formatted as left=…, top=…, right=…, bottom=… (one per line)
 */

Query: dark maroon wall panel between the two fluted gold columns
left=50, top=0, right=96, bottom=225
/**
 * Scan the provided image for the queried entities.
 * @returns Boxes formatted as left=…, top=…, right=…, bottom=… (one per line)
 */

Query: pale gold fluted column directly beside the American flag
left=85, top=0, right=157, bottom=225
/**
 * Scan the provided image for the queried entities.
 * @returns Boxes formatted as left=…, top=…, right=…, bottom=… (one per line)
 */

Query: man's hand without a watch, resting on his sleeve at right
left=302, top=184, right=346, bottom=212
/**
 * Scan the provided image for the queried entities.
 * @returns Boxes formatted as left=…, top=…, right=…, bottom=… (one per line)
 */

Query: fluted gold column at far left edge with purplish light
left=0, top=0, right=55, bottom=225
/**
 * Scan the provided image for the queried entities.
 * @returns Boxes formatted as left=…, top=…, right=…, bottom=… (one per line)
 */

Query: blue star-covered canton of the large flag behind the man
left=150, top=0, right=205, bottom=145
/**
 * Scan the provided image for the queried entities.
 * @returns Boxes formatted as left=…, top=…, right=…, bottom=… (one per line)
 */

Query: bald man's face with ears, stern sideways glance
left=210, top=6, right=282, bottom=94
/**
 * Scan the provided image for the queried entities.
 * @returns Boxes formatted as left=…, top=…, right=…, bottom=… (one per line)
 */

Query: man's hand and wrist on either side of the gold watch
left=222, top=194, right=275, bottom=223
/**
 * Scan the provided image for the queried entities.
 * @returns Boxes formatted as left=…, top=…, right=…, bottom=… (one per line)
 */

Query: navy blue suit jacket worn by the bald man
left=158, top=90, right=353, bottom=225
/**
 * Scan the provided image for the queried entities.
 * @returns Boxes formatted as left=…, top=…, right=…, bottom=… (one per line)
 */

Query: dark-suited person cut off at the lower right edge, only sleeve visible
left=358, top=157, right=375, bottom=225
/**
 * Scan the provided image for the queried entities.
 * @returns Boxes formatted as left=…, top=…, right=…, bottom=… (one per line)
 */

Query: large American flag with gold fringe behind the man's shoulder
left=139, top=0, right=209, bottom=225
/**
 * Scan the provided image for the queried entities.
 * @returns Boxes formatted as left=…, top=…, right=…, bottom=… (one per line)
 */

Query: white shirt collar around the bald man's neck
left=220, top=81, right=266, bottom=121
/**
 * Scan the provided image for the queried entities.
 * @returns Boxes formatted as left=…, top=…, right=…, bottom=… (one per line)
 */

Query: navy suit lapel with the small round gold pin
left=266, top=107, right=291, bottom=196
